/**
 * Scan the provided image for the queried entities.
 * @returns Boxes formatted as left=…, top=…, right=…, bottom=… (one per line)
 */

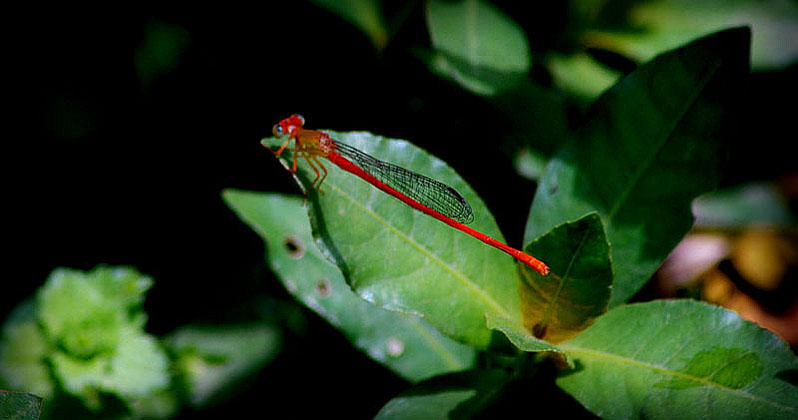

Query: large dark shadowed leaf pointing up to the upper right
left=525, top=28, right=750, bottom=307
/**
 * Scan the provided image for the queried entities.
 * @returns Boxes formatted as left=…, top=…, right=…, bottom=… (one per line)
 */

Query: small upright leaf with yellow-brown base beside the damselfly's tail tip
left=519, top=213, right=612, bottom=343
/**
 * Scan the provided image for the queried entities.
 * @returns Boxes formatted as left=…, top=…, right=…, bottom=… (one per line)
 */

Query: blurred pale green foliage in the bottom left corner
left=0, top=267, right=279, bottom=418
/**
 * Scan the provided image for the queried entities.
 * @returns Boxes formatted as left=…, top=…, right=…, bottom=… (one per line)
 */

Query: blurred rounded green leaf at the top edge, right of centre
left=427, top=0, right=530, bottom=96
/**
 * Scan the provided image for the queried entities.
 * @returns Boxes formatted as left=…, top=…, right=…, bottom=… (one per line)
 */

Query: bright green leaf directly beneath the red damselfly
left=263, top=130, right=520, bottom=348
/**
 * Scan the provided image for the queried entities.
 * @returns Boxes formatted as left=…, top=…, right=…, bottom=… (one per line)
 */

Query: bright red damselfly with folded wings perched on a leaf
left=264, top=114, right=550, bottom=276
